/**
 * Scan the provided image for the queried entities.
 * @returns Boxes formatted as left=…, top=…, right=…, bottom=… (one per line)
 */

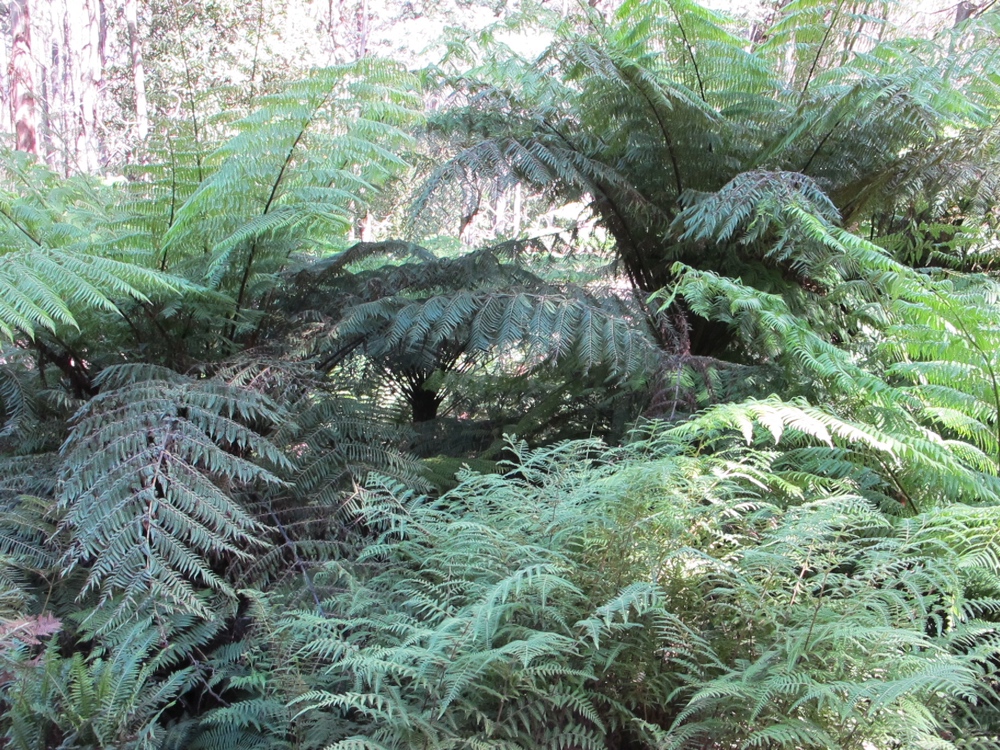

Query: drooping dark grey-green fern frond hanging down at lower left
left=60, top=366, right=288, bottom=627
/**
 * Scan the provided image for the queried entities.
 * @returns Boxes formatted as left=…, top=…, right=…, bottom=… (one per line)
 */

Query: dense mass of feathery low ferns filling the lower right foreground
left=227, top=440, right=998, bottom=748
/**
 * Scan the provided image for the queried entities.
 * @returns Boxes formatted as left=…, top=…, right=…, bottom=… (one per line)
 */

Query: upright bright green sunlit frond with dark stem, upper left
left=163, top=60, right=416, bottom=320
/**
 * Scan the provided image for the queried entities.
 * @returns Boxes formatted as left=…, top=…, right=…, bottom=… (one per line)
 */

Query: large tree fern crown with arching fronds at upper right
left=417, top=0, right=997, bottom=357
